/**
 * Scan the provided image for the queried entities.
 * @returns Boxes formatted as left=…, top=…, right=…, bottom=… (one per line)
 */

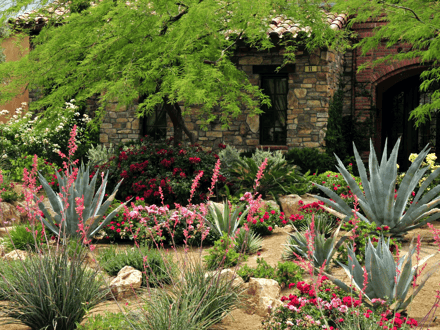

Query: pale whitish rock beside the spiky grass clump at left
left=110, top=266, right=142, bottom=299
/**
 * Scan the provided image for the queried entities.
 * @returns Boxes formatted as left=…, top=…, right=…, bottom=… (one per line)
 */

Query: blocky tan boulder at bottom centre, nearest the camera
left=246, top=277, right=282, bottom=317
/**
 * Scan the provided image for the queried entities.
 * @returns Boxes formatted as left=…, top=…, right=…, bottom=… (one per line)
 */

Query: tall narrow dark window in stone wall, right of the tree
left=260, top=74, right=288, bottom=145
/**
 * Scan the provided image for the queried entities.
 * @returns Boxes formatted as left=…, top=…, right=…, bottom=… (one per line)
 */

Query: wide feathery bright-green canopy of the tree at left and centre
left=0, top=0, right=342, bottom=141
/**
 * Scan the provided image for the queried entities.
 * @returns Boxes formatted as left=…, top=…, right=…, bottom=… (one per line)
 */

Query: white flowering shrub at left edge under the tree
left=0, top=100, right=98, bottom=173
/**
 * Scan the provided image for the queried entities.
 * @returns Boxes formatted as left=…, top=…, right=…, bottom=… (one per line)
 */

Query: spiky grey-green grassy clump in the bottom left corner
left=0, top=242, right=108, bottom=330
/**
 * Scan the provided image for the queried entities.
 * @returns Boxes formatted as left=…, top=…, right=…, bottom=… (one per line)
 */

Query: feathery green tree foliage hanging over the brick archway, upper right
left=333, top=0, right=440, bottom=125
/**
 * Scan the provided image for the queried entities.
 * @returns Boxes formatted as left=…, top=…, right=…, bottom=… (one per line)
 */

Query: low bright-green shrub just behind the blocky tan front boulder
left=237, top=258, right=304, bottom=286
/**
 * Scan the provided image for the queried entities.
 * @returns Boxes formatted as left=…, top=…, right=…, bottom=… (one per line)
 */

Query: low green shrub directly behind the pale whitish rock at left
left=98, top=246, right=176, bottom=286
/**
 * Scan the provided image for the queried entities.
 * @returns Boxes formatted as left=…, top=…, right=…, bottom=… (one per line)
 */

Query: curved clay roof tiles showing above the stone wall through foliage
left=268, top=13, right=348, bottom=38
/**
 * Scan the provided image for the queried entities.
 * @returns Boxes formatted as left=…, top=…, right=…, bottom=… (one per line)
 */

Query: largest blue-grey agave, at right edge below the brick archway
left=315, top=139, right=440, bottom=236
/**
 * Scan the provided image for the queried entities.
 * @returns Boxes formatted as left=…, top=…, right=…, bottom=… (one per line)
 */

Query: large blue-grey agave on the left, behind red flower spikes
left=34, top=164, right=124, bottom=239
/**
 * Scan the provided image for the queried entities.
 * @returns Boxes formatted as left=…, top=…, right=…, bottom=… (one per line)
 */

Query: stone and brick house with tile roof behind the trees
left=1, top=10, right=440, bottom=163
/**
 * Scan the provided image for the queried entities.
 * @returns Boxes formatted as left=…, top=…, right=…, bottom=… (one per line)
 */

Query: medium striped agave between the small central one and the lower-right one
left=282, top=220, right=347, bottom=271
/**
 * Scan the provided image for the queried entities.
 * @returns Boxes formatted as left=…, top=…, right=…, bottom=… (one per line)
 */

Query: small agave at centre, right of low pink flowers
left=206, top=201, right=249, bottom=237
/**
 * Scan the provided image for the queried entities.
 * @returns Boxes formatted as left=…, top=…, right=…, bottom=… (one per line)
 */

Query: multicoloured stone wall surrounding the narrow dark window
left=100, top=48, right=343, bottom=150
